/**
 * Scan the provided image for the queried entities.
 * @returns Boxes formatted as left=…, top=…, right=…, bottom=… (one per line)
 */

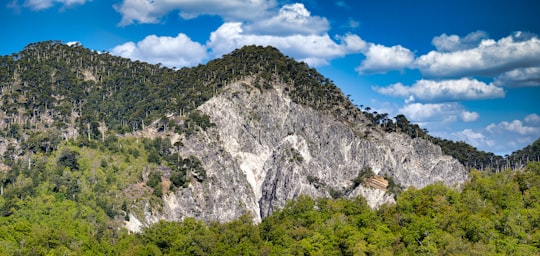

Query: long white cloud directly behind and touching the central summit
left=207, top=22, right=366, bottom=66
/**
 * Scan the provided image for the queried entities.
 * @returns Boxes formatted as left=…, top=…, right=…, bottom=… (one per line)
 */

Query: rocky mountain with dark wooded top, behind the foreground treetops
left=0, top=41, right=468, bottom=231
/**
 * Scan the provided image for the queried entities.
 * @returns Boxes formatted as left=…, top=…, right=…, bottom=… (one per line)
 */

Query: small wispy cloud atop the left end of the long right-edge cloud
left=431, top=31, right=487, bottom=52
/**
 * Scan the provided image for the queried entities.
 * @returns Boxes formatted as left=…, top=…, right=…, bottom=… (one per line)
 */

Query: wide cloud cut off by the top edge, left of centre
left=114, top=0, right=277, bottom=26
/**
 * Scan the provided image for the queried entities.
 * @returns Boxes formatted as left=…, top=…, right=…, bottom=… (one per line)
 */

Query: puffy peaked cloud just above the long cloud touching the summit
left=245, top=3, right=330, bottom=35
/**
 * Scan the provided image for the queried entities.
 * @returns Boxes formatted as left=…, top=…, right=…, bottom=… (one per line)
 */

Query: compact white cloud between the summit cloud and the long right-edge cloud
left=356, top=44, right=414, bottom=74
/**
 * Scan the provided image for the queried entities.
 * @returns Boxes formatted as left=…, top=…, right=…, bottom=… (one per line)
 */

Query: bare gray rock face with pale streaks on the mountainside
left=126, top=80, right=467, bottom=231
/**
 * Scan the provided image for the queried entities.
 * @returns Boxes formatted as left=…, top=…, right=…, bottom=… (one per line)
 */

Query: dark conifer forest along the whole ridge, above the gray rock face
left=0, top=41, right=540, bottom=170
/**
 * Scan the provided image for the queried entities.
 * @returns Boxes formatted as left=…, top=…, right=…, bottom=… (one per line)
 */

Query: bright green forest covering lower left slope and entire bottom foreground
left=0, top=136, right=540, bottom=255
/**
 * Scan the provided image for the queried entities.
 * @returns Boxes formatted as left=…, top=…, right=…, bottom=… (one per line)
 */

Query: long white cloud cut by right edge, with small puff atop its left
left=415, top=32, right=540, bottom=77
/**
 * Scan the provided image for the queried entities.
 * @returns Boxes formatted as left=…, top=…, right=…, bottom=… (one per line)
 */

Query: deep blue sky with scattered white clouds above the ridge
left=0, top=0, right=540, bottom=156
